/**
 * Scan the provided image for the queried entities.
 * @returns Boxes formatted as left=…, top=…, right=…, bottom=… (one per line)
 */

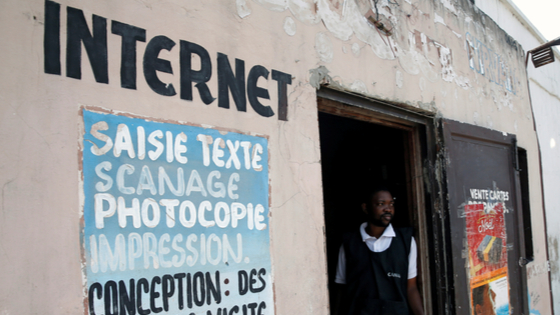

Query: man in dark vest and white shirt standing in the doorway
left=335, top=188, right=424, bottom=315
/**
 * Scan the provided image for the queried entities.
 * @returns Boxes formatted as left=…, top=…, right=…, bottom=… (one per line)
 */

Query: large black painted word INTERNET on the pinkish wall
left=43, top=0, right=292, bottom=120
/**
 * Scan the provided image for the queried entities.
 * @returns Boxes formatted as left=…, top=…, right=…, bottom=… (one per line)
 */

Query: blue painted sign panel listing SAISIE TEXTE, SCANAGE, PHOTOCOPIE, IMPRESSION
left=82, top=109, right=274, bottom=315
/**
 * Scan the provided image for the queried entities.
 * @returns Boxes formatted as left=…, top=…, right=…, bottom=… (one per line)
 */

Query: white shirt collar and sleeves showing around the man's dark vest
left=334, top=222, right=417, bottom=284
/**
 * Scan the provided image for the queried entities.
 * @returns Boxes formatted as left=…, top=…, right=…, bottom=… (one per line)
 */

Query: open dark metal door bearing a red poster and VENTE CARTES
left=441, top=119, right=528, bottom=315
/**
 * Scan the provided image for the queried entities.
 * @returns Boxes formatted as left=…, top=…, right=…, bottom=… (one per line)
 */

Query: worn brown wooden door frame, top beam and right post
left=317, top=87, right=454, bottom=314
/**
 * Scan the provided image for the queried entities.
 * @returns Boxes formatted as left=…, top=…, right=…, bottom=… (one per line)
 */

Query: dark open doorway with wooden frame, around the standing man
left=318, top=90, right=433, bottom=314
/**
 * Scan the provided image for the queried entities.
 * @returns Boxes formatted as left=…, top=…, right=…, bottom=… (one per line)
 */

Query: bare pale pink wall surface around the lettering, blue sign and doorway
left=0, top=0, right=550, bottom=314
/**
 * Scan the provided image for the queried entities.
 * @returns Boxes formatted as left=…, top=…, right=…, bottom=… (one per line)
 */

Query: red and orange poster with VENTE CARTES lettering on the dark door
left=465, top=190, right=509, bottom=315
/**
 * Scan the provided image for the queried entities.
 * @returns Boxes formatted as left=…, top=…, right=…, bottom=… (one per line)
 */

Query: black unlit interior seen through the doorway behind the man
left=319, top=112, right=410, bottom=310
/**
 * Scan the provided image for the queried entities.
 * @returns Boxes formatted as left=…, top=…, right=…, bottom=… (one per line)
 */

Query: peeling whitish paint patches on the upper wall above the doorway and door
left=249, top=0, right=515, bottom=95
